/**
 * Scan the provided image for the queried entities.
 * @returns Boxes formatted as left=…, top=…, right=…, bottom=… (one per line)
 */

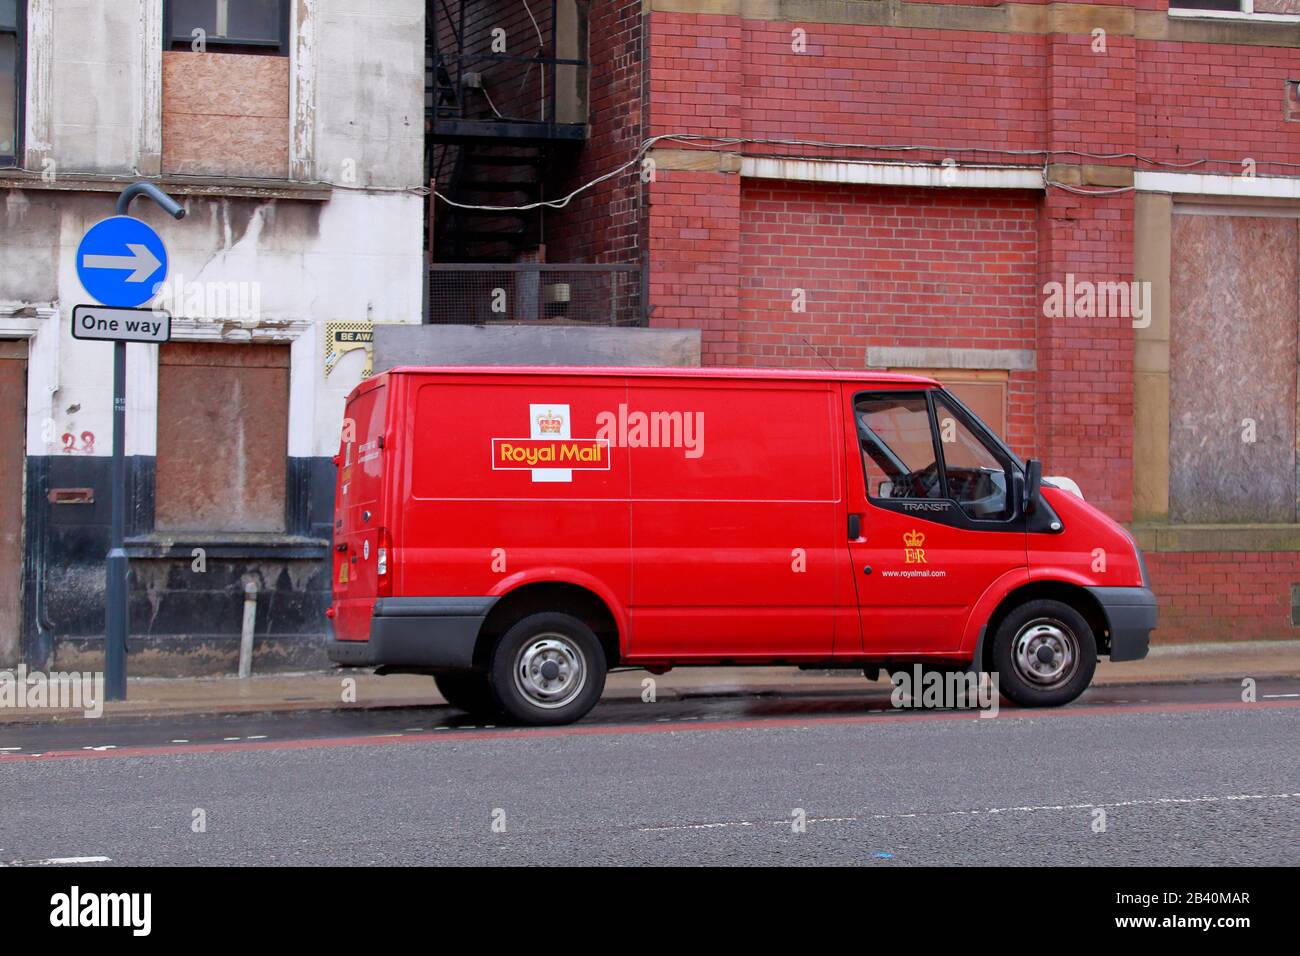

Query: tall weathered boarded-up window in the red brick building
left=1169, top=213, right=1300, bottom=523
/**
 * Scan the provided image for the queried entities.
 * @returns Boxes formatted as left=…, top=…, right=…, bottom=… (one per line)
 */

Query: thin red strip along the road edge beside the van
left=0, top=700, right=1300, bottom=766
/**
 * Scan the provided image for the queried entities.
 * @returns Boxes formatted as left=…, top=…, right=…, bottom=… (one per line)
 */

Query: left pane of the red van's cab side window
left=854, top=393, right=944, bottom=498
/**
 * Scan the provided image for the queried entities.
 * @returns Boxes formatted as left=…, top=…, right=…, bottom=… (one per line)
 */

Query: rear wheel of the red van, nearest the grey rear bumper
left=488, top=611, right=607, bottom=726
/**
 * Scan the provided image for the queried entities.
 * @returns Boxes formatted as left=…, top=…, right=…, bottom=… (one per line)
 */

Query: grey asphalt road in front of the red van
left=0, top=680, right=1300, bottom=866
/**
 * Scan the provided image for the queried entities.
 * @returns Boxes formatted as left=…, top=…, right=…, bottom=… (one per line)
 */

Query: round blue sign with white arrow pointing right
left=77, top=216, right=166, bottom=308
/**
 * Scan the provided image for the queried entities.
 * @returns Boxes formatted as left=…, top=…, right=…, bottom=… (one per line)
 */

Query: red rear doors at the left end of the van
left=333, top=381, right=391, bottom=640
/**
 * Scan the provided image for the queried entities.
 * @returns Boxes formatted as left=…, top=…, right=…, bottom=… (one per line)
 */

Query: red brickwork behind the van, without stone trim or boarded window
left=624, top=0, right=1300, bottom=643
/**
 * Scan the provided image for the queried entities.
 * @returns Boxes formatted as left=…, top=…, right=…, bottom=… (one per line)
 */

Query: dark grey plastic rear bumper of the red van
left=325, top=597, right=497, bottom=670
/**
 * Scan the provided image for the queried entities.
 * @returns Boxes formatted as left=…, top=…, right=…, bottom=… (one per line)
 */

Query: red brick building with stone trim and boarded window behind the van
left=436, top=0, right=1300, bottom=643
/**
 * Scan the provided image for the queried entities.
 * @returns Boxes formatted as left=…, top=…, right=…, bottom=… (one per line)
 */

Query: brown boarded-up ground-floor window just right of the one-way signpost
left=155, top=342, right=289, bottom=532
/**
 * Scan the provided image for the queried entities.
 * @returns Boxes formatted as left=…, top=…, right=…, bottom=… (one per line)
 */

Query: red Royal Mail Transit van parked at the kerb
left=329, top=368, right=1156, bottom=724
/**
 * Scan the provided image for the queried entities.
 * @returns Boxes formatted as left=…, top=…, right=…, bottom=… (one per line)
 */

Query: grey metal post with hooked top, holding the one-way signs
left=104, top=182, right=185, bottom=700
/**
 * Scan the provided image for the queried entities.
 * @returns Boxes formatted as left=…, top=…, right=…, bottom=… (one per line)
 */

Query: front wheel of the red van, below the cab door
left=993, top=600, right=1097, bottom=708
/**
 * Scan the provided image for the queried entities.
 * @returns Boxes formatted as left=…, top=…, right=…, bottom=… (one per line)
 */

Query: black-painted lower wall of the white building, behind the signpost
left=22, top=455, right=334, bottom=676
